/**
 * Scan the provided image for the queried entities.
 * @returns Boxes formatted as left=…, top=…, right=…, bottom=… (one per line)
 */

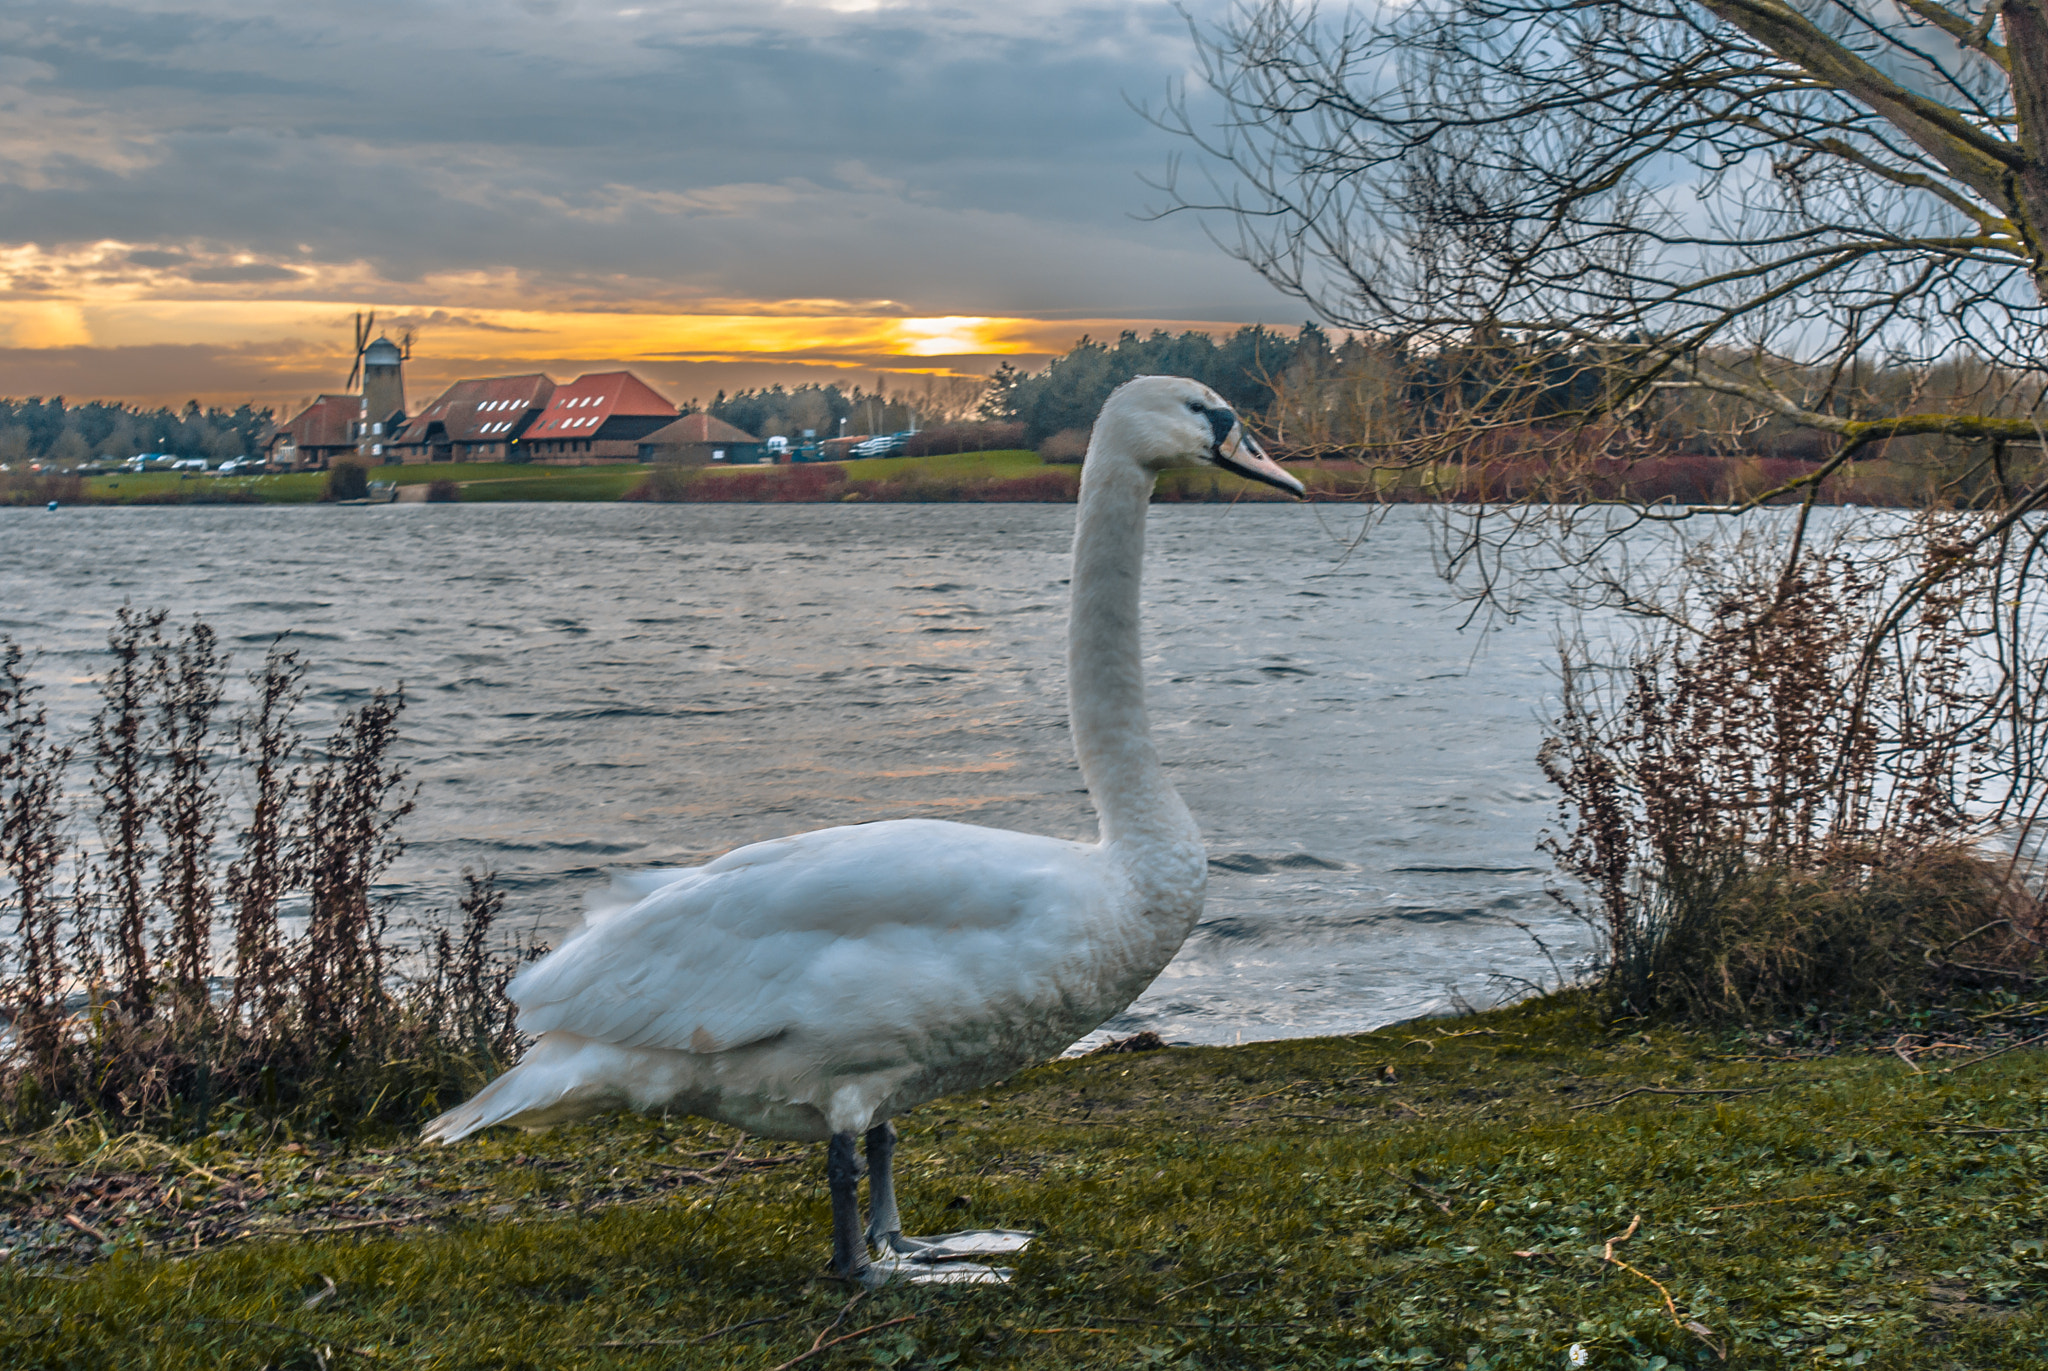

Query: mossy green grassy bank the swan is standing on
left=0, top=996, right=2048, bottom=1371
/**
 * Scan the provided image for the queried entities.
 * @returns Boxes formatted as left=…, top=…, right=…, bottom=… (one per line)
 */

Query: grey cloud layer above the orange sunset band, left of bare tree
left=0, top=2, right=1298, bottom=318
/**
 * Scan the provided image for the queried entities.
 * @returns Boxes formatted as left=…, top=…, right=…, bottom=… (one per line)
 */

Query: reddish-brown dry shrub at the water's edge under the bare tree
left=1542, top=516, right=2048, bottom=1019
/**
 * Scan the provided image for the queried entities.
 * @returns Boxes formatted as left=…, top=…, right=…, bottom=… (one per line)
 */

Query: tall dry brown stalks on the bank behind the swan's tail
left=0, top=609, right=536, bottom=1133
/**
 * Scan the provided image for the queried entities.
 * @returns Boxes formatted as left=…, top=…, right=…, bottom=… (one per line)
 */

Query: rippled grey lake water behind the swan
left=0, top=504, right=1583, bottom=1043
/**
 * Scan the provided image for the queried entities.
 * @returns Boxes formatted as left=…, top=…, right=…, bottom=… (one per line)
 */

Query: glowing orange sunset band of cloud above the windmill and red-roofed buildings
left=0, top=240, right=1269, bottom=404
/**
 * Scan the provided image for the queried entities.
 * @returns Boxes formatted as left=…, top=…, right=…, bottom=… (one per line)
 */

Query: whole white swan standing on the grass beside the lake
left=424, top=368, right=1303, bottom=1285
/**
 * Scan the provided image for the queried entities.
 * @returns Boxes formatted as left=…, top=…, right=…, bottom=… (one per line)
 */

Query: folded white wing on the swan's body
left=510, top=820, right=1108, bottom=1053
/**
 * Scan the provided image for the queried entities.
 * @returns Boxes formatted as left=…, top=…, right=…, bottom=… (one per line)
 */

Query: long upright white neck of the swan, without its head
left=1067, top=461, right=1202, bottom=867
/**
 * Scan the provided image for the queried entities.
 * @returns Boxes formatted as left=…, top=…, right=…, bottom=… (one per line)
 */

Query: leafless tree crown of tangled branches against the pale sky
left=1153, top=0, right=2048, bottom=483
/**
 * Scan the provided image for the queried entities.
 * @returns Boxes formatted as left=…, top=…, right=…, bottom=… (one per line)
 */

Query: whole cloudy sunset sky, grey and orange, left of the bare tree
left=0, top=0, right=1305, bottom=408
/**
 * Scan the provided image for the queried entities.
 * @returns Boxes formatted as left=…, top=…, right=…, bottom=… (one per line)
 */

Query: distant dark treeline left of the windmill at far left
left=0, top=396, right=276, bottom=465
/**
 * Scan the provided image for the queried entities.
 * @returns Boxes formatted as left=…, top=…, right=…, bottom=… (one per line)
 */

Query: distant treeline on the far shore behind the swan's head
left=981, top=324, right=2044, bottom=481
